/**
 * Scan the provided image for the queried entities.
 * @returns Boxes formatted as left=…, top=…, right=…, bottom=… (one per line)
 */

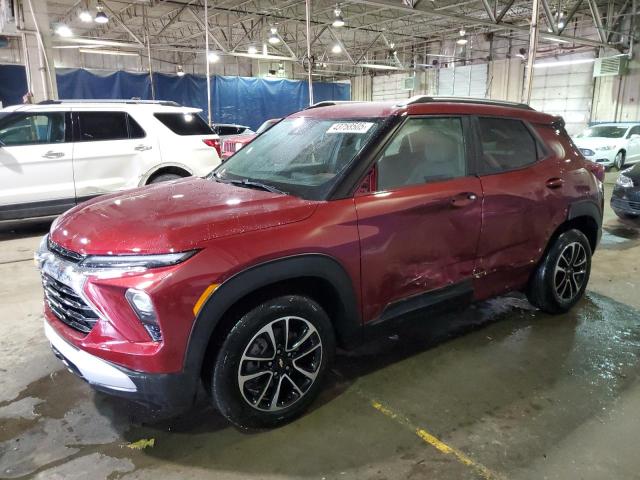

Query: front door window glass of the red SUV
left=378, top=117, right=467, bottom=190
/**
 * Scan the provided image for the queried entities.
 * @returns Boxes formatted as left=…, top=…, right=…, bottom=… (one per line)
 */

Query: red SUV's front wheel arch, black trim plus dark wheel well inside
left=184, top=254, right=362, bottom=382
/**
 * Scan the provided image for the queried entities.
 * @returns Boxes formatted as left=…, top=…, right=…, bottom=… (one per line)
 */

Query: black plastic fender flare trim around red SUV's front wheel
left=184, top=254, right=362, bottom=374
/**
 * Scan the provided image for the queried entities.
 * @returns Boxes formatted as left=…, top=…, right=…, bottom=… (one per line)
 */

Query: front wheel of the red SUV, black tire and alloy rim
left=211, top=295, right=335, bottom=429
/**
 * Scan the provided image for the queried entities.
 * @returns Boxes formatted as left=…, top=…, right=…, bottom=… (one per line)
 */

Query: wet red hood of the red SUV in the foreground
left=51, top=178, right=316, bottom=255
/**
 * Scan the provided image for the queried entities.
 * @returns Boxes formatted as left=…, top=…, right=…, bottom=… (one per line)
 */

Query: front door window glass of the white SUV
left=0, top=112, right=65, bottom=146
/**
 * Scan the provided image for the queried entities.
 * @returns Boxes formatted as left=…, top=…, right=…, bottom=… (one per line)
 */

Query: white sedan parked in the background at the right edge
left=574, top=123, right=640, bottom=170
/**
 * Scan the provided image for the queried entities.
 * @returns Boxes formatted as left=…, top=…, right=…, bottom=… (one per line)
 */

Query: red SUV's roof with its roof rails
left=291, top=96, right=558, bottom=123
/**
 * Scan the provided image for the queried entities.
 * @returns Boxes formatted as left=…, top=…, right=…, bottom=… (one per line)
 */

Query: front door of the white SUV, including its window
left=0, top=111, right=75, bottom=220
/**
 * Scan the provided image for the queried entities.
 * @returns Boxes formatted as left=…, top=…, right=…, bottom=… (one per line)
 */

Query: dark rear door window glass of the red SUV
left=479, top=118, right=538, bottom=174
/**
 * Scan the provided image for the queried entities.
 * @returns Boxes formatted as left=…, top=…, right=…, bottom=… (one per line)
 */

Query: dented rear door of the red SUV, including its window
left=475, top=117, right=566, bottom=297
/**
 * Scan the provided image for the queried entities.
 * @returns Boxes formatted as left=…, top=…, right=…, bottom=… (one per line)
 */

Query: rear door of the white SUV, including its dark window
left=73, top=109, right=160, bottom=200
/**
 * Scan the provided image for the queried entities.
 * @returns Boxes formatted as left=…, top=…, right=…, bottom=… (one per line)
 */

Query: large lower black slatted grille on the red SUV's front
left=42, top=273, right=98, bottom=333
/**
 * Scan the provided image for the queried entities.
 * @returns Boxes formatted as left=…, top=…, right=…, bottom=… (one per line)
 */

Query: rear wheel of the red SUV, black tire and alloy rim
left=527, top=230, right=591, bottom=313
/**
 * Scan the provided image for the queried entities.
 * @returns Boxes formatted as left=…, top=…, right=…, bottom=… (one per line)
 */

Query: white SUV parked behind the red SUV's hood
left=0, top=100, right=220, bottom=222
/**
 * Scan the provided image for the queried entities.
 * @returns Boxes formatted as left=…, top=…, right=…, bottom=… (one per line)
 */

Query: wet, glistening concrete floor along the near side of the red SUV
left=0, top=293, right=640, bottom=478
